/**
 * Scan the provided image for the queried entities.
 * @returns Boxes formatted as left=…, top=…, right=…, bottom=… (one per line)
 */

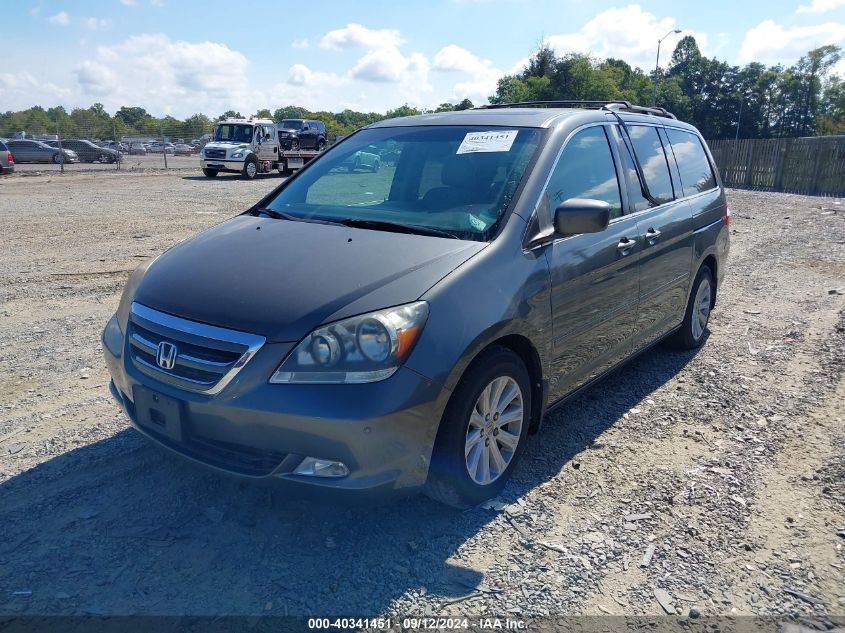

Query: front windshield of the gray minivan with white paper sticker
left=266, top=126, right=541, bottom=241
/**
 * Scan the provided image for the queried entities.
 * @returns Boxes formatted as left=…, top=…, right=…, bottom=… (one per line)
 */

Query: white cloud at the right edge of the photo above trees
left=739, top=20, right=845, bottom=64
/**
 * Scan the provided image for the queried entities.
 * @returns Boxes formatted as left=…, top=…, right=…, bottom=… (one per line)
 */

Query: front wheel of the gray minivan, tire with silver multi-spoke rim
left=425, top=347, right=531, bottom=509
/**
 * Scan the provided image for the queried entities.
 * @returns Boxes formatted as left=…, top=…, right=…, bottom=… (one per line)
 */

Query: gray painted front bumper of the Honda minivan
left=102, top=319, right=447, bottom=497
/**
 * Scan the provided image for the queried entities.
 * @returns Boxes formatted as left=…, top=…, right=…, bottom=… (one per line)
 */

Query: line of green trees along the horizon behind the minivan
left=0, top=36, right=845, bottom=139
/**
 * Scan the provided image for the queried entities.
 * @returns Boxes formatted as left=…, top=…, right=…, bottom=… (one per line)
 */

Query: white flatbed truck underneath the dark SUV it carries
left=200, top=119, right=319, bottom=180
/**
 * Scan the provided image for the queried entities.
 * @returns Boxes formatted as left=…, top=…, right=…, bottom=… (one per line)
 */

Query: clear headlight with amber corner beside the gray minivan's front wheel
left=270, top=301, right=428, bottom=384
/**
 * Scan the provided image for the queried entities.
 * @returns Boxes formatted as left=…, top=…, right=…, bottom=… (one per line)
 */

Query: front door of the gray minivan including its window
left=546, top=125, right=642, bottom=401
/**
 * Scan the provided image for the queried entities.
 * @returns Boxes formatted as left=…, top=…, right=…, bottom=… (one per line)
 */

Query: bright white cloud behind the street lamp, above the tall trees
left=547, top=4, right=707, bottom=69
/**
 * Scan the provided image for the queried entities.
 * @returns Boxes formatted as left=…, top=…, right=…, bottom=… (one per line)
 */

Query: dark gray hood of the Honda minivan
left=135, top=215, right=486, bottom=341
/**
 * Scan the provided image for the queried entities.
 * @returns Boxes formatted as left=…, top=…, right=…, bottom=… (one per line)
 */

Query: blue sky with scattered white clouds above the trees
left=0, top=0, right=845, bottom=118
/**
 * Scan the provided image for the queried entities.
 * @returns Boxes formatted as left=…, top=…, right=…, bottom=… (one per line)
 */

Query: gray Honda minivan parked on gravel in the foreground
left=102, top=102, right=730, bottom=507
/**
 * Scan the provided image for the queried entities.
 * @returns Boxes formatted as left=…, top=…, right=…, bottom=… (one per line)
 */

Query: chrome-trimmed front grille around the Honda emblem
left=127, top=303, right=265, bottom=394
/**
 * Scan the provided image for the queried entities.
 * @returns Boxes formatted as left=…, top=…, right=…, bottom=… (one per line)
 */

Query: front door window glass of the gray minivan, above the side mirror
left=546, top=126, right=622, bottom=218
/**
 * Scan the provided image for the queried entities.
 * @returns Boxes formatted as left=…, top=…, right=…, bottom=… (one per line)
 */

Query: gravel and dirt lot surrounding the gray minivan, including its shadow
left=0, top=171, right=845, bottom=618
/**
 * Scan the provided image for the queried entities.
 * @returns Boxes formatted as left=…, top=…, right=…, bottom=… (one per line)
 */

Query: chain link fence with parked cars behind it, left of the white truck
left=0, top=117, right=214, bottom=173
